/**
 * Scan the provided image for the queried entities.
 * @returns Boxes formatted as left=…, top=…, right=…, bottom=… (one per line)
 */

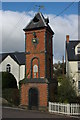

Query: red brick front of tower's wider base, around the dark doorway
left=21, top=83, right=48, bottom=107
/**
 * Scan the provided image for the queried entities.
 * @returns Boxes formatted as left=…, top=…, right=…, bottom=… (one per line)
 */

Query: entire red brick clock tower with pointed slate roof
left=21, top=12, right=57, bottom=109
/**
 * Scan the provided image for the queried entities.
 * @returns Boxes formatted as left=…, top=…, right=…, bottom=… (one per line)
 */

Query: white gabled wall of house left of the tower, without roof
left=0, top=56, right=25, bottom=87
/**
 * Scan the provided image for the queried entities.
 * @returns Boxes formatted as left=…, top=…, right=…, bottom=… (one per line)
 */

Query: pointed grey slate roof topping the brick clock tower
left=23, top=12, right=54, bottom=34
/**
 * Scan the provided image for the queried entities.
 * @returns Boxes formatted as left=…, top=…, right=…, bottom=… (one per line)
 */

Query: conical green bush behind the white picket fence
left=57, top=76, right=77, bottom=103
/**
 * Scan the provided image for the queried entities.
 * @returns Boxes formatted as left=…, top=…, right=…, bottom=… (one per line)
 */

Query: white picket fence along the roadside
left=49, top=102, right=80, bottom=115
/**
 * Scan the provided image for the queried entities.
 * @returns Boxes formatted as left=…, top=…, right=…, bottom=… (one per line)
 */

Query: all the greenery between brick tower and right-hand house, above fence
left=53, top=62, right=79, bottom=103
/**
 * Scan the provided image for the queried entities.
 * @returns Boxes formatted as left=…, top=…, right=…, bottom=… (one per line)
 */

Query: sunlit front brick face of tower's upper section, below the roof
left=25, top=29, right=45, bottom=78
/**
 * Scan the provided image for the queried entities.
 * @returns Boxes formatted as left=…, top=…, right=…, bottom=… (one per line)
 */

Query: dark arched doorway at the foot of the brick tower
left=29, top=88, right=38, bottom=109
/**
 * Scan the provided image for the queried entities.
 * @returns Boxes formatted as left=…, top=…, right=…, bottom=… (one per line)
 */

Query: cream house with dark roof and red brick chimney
left=66, top=35, right=80, bottom=95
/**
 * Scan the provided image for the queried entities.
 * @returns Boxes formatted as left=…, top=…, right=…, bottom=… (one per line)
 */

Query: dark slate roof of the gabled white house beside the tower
left=0, top=52, right=25, bottom=65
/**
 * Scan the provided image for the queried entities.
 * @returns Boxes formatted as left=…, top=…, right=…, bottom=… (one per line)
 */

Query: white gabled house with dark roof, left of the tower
left=0, top=52, right=25, bottom=87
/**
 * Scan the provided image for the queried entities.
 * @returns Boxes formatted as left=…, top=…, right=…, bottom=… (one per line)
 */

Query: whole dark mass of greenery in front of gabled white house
left=0, top=72, right=20, bottom=105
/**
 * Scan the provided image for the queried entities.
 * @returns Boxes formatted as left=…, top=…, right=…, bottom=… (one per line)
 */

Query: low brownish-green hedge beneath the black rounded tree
left=2, top=88, right=20, bottom=105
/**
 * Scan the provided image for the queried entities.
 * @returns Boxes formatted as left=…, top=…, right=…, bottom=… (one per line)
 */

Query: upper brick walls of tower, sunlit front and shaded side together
left=25, top=29, right=53, bottom=78
